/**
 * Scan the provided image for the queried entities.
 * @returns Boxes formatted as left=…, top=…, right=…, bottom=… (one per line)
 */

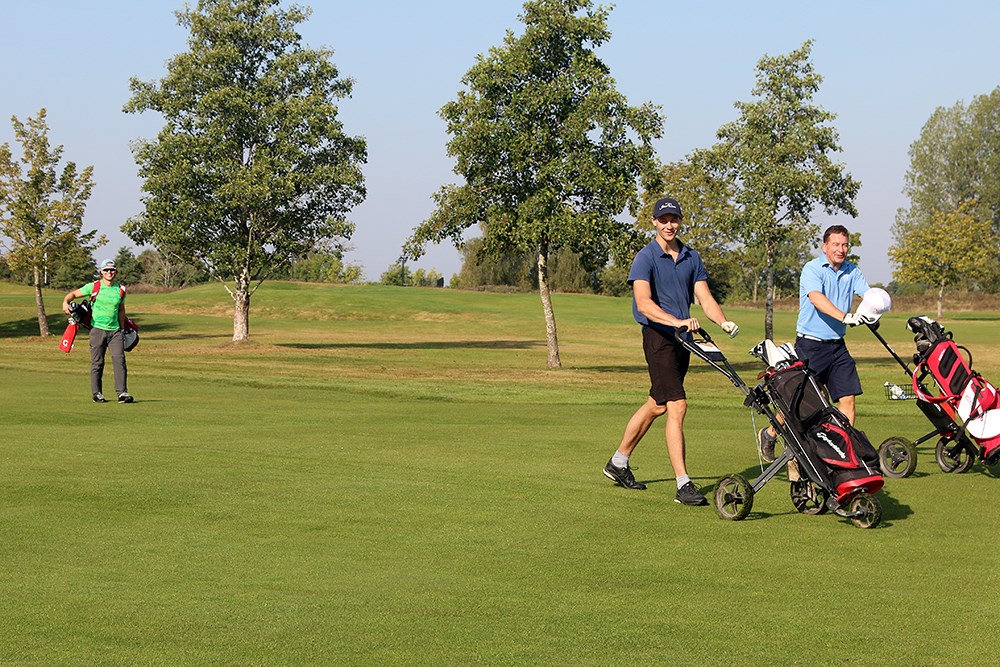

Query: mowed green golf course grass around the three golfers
left=0, top=283, right=1000, bottom=665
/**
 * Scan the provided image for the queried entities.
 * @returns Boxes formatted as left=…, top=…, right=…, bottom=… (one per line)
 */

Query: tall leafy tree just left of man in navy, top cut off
left=404, top=0, right=662, bottom=368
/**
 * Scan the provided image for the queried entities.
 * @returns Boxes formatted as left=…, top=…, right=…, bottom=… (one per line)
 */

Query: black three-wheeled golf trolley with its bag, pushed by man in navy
left=675, top=329, right=884, bottom=528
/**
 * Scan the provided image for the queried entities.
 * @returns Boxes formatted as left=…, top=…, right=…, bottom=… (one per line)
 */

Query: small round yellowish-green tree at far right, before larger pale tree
left=889, top=206, right=996, bottom=317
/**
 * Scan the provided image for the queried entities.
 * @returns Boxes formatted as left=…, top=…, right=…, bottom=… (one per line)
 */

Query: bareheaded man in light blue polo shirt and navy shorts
left=757, top=225, right=870, bottom=461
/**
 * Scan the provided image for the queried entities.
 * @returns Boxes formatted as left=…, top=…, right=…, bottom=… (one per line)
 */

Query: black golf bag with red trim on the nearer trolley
left=763, top=359, right=884, bottom=503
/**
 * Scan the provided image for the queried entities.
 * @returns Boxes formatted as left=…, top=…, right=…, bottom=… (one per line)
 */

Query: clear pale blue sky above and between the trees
left=0, top=0, right=1000, bottom=282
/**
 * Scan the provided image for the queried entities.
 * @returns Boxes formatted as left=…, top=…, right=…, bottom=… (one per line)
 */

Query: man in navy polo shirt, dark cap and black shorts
left=604, top=198, right=740, bottom=505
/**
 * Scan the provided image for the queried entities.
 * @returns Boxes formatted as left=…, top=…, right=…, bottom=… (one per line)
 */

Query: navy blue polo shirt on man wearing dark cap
left=628, top=239, right=708, bottom=336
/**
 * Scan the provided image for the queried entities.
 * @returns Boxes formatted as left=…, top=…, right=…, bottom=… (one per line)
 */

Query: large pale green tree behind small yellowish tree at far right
left=893, top=87, right=1000, bottom=291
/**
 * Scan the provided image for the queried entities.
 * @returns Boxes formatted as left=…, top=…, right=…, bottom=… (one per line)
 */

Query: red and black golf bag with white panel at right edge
left=906, top=317, right=1000, bottom=465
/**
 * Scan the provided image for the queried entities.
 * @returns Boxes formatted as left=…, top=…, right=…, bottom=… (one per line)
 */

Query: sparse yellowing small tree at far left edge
left=0, top=109, right=105, bottom=336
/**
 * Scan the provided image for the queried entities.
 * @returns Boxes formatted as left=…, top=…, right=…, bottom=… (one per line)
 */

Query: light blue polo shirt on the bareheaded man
left=795, top=255, right=869, bottom=340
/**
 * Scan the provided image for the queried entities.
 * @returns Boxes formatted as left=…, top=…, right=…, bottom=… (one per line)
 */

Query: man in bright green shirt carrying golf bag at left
left=63, top=259, right=135, bottom=403
